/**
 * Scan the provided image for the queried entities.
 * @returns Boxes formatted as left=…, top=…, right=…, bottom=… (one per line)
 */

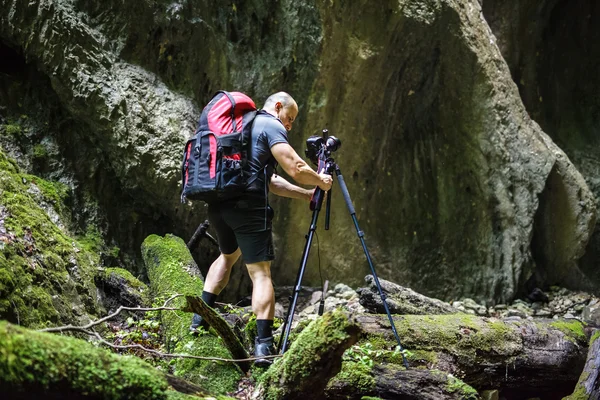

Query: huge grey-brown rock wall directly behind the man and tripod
left=0, top=0, right=596, bottom=302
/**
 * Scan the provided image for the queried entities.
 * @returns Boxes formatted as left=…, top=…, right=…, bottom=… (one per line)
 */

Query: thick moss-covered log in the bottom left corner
left=0, top=322, right=168, bottom=400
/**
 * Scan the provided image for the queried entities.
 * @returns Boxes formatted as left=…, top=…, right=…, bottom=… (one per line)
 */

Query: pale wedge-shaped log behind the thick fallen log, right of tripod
left=357, top=275, right=460, bottom=315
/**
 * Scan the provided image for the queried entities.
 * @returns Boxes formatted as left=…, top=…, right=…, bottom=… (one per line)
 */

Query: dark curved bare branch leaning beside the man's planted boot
left=183, top=296, right=250, bottom=373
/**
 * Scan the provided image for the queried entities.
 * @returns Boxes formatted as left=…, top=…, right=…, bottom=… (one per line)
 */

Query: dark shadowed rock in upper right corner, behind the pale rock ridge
left=483, top=0, right=600, bottom=287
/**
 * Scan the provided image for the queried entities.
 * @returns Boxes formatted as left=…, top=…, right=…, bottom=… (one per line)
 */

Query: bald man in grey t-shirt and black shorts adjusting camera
left=190, top=92, right=333, bottom=366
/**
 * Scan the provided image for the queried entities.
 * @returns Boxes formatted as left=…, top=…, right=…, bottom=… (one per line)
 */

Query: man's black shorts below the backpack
left=208, top=198, right=275, bottom=264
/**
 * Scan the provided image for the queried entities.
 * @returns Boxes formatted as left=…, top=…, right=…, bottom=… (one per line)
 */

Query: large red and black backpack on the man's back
left=181, top=91, right=258, bottom=203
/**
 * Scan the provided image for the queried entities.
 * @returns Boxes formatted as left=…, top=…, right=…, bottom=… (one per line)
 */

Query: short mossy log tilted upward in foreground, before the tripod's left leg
left=253, top=310, right=360, bottom=400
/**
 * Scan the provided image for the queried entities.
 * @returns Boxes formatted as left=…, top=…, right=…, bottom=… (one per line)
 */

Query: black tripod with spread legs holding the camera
left=278, top=155, right=408, bottom=368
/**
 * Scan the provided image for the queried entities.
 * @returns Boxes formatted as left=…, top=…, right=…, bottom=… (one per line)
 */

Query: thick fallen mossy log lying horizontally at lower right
left=356, top=314, right=588, bottom=398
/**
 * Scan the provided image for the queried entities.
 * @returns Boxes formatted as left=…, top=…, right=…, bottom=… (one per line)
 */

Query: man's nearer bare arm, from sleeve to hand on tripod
left=271, top=143, right=333, bottom=191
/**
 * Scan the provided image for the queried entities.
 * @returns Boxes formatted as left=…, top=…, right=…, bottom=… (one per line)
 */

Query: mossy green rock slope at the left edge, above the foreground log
left=0, top=151, right=100, bottom=327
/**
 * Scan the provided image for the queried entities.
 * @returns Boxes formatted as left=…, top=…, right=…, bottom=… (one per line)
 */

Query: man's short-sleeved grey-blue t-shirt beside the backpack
left=247, top=110, right=288, bottom=198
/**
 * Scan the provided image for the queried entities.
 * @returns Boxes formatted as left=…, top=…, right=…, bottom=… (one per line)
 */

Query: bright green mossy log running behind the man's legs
left=142, top=235, right=242, bottom=394
